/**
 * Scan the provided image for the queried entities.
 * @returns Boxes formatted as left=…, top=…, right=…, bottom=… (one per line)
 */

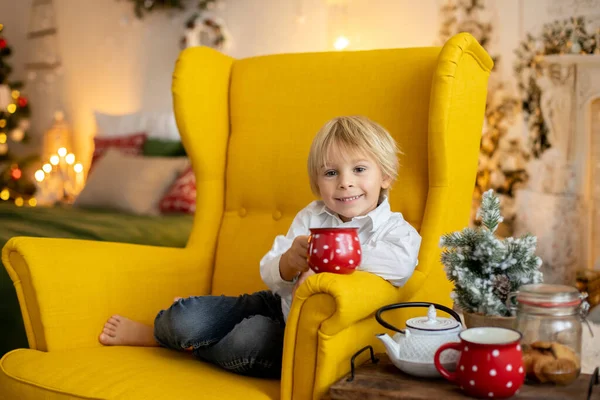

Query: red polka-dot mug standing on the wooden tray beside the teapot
left=433, top=327, right=525, bottom=398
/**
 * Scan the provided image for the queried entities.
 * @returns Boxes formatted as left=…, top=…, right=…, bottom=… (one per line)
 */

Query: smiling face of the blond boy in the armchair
left=317, top=146, right=390, bottom=222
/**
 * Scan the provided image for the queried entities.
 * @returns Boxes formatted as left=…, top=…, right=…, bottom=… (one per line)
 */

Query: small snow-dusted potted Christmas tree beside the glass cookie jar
left=440, top=189, right=542, bottom=317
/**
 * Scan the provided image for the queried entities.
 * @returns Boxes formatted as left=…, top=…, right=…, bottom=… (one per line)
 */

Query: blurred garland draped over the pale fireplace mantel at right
left=514, top=17, right=600, bottom=157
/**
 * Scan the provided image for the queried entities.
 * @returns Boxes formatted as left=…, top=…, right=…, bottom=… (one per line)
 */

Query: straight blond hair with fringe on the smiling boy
left=308, top=115, right=402, bottom=196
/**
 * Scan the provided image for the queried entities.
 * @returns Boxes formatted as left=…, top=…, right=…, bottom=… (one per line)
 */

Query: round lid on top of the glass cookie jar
left=517, top=283, right=582, bottom=307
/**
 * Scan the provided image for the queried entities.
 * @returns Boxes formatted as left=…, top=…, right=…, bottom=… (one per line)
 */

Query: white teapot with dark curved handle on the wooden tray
left=375, top=302, right=462, bottom=378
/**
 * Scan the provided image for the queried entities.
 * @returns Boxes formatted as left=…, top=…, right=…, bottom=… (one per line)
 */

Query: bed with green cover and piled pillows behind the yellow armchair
left=0, top=110, right=196, bottom=356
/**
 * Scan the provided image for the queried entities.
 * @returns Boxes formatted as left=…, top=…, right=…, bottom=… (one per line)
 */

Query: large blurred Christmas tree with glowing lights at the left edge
left=0, top=24, right=36, bottom=206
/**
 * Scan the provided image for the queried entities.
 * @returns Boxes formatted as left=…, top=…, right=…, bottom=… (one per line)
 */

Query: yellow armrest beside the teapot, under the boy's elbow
left=281, top=271, right=404, bottom=399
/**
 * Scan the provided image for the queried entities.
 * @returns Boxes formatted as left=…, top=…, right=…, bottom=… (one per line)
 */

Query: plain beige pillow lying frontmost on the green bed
left=74, top=149, right=189, bottom=215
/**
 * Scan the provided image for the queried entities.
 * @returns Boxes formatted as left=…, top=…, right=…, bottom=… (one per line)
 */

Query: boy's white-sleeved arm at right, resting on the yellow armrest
left=358, top=219, right=421, bottom=286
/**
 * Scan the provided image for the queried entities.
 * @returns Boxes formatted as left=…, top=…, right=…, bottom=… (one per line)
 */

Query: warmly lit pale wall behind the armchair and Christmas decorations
left=0, top=0, right=590, bottom=166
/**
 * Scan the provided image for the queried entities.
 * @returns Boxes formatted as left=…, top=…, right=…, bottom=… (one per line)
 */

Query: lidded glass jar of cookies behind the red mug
left=508, top=283, right=589, bottom=385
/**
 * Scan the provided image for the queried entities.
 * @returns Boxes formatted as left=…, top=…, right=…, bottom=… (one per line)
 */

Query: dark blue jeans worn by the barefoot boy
left=154, top=291, right=285, bottom=378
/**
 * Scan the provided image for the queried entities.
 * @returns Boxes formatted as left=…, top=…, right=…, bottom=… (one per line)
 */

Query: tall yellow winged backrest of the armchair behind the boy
left=173, top=34, right=491, bottom=294
